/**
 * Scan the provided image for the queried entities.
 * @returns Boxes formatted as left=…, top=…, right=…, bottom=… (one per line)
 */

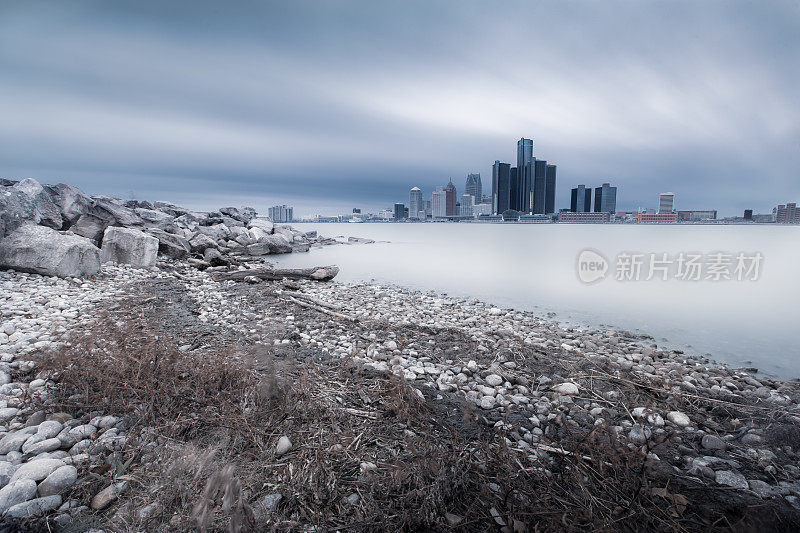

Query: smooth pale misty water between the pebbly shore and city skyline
left=271, top=223, right=800, bottom=378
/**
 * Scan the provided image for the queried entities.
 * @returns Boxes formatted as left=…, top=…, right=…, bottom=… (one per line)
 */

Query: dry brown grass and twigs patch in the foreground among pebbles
left=26, top=296, right=800, bottom=531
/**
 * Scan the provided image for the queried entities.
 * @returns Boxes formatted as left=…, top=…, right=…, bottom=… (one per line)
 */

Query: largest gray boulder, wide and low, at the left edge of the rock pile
left=0, top=224, right=100, bottom=278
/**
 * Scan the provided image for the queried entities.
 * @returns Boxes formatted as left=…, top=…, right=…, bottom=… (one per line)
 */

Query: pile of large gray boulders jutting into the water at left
left=0, top=178, right=326, bottom=277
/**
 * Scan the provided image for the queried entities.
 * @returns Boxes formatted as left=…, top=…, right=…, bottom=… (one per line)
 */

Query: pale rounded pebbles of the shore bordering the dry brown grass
left=0, top=261, right=800, bottom=527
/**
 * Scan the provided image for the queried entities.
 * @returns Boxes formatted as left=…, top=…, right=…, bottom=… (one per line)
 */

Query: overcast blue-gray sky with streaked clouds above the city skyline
left=0, top=0, right=800, bottom=215
